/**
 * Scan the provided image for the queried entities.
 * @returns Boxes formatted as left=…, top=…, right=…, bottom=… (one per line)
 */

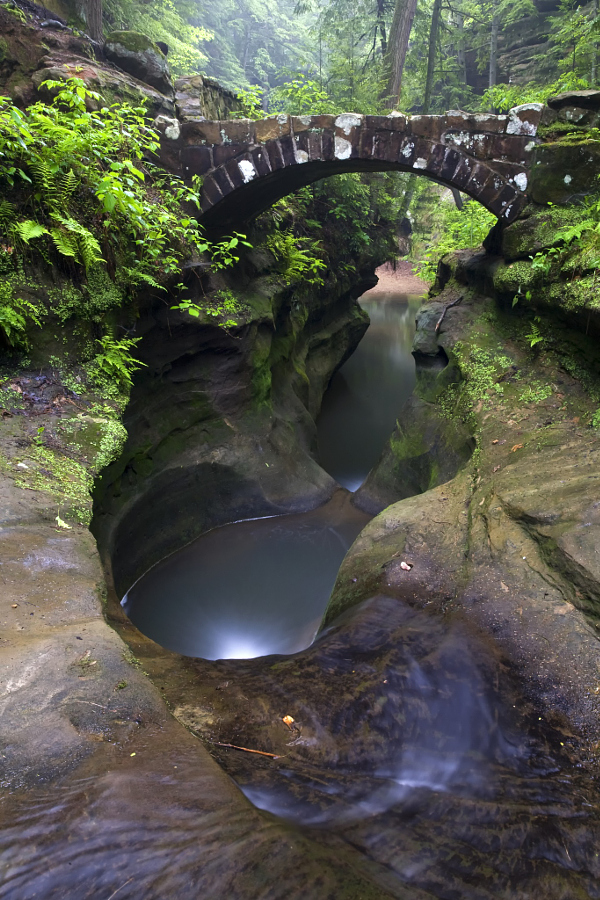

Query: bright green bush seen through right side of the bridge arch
left=415, top=200, right=496, bottom=281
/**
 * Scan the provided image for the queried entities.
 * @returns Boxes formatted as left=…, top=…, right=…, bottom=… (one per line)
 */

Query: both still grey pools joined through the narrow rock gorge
left=122, top=292, right=422, bottom=659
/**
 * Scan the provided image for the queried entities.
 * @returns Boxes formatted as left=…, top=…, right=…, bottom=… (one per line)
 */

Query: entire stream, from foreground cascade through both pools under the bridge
left=0, top=284, right=600, bottom=900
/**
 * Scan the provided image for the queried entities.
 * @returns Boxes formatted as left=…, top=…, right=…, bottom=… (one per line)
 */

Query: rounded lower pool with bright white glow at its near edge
left=122, top=491, right=369, bottom=659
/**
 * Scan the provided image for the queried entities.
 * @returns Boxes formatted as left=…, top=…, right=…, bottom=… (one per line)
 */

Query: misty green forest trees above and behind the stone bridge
left=87, top=0, right=600, bottom=113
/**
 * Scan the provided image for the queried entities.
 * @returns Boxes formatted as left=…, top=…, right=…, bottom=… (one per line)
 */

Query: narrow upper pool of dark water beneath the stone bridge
left=317, top=293, right=423, bottom=491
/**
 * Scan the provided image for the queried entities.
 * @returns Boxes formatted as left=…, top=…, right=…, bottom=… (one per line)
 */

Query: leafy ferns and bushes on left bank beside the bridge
left=0, top=78, right=249, bottom=344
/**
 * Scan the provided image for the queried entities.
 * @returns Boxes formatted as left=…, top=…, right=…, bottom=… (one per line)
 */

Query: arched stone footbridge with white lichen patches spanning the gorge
left=156, top=104, right=542, bottom=231
